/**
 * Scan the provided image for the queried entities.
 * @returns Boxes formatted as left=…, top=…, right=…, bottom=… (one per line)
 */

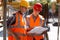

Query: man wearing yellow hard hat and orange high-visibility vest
left=7, top=1, right=29, bottom=40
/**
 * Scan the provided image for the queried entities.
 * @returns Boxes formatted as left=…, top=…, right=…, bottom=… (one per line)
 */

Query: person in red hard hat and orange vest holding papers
left=26, top=3, right=44, bottom=40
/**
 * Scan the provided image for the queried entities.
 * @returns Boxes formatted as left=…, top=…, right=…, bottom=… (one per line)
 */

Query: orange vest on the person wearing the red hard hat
left=27, top=15, right=44, bottom=40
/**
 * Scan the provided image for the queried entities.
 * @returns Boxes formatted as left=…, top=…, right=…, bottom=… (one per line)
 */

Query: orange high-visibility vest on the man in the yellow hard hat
left=8, top=12, right=27, bottom=40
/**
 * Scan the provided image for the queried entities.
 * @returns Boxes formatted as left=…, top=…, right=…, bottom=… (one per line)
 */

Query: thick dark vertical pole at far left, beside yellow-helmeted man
left=3, top=0, right=7, bottom=40
